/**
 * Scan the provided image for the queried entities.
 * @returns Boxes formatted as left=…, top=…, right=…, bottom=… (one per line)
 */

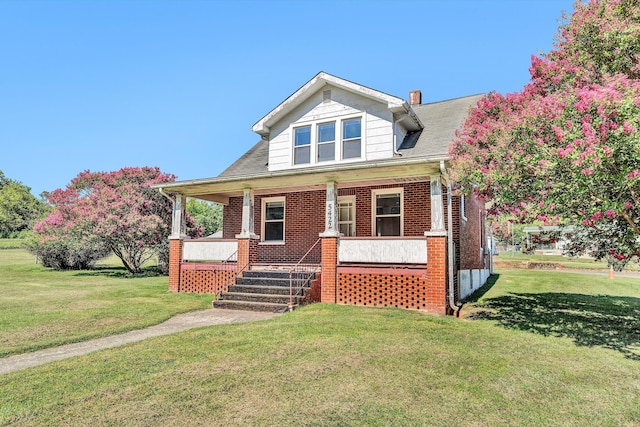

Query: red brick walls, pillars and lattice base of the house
left=175, top=177, right=484, bottom=314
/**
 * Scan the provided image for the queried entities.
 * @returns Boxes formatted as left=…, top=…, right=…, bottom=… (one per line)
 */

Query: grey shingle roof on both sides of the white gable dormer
left=218, top=94, right=484, bottom=177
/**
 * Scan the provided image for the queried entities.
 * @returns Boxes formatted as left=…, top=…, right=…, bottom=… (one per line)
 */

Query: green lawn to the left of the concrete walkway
left=0, top=249, right=212, bottom=357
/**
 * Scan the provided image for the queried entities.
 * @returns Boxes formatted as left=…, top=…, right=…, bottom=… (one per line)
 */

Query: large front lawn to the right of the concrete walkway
left=0, top=270, right=640, bottom=426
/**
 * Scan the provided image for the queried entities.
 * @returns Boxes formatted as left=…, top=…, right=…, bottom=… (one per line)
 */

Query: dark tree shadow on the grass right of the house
left=469, top=291, right=640, bottom=361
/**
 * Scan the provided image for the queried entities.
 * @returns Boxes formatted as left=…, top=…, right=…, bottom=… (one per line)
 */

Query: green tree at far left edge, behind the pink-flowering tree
left=0, top=171, right=46, bottom=237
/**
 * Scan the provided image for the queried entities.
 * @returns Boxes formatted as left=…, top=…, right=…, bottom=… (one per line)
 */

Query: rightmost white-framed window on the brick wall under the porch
left=372, top=188, right=403, bottom=236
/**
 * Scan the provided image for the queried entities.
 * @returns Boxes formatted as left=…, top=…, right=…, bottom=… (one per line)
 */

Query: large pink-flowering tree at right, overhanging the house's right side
left=451, top=0, right=640, bottom=266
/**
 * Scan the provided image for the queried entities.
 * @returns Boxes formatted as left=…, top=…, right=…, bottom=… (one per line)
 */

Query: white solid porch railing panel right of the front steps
left=338, top=237, right=427, bottom=264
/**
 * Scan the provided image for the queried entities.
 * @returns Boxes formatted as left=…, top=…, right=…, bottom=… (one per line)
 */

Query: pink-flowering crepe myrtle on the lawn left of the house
left=34, top=167, right=202, bottom=273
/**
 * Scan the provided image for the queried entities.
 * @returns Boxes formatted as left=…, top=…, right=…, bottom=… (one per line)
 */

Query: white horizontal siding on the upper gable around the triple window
left=269, top=86, right=400, bottom=171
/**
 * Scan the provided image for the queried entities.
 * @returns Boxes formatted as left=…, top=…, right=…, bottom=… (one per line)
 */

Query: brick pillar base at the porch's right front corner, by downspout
left=425, top=231, right=447, bottom=314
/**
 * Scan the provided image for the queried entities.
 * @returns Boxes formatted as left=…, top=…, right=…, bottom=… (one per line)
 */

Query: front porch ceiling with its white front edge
left=153, top=160, right=440, bottom=204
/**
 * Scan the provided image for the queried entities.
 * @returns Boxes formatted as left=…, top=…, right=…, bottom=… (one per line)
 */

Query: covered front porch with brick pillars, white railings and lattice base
left=161, top=162, right=448, bottom=314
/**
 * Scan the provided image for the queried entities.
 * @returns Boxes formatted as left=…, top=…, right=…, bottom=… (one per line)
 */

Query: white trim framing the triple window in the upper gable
left=289, top=111, right=367, bottom=169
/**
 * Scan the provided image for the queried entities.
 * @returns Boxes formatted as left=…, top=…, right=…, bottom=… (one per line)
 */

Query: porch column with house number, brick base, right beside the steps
left=320, top=182, right=340, bottom=303
